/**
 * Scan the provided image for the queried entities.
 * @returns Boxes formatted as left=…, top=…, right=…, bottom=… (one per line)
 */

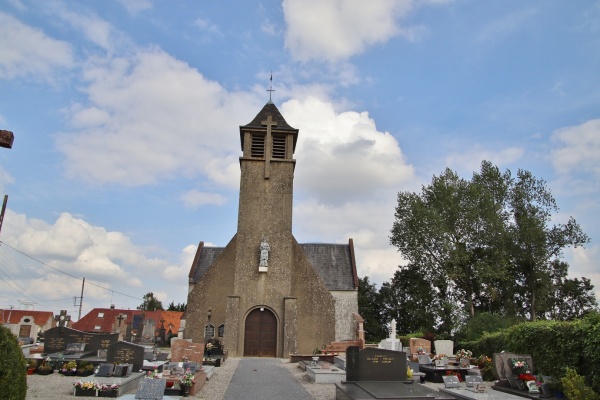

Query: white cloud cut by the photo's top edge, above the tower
left=283, top=0, right=413, bottom=61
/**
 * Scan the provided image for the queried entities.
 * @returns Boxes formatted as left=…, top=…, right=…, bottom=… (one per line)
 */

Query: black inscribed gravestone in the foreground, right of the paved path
left=346, top=346, right=407, bottom=382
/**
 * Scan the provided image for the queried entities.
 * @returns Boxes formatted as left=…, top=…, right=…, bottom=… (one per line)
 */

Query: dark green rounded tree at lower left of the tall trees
left=379, top=264, right=439, bottom=334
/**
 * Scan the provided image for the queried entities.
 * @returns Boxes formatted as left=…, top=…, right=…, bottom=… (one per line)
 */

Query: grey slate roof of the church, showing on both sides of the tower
left=189, top=239, right=358, bottom=290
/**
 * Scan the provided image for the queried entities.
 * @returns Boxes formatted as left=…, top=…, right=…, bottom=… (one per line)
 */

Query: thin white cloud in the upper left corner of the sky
left=0, top=12, right=74, bottom=82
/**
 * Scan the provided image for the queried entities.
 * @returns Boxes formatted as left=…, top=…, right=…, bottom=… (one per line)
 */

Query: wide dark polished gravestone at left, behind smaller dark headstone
left=44, top=326, right=119, bottom=354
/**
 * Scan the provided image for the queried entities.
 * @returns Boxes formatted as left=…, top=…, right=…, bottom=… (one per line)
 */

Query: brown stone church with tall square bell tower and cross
left=183, top=100, right=361, bottom=357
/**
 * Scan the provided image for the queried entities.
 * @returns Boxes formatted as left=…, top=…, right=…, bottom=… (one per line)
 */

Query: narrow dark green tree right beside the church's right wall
left=358, top=276, right=388, bottom=342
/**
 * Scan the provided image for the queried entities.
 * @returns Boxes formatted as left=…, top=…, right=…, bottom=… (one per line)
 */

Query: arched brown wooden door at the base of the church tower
left=244, top=308, right=277, bottom=357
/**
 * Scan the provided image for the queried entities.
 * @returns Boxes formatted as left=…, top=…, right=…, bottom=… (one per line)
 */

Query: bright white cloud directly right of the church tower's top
left=282, top=97, right=414, bottom=204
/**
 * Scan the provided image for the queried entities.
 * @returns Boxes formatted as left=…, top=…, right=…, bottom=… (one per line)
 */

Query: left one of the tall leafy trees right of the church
left=390, top=162, right=508, bottom=324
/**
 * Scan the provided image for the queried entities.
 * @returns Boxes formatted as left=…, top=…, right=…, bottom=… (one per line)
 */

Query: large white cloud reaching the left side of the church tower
left=56, top=50, right=259, bottom=186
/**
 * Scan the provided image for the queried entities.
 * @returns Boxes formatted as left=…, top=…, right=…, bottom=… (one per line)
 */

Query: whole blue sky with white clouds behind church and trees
left=0, top=0, right=600, bottom=316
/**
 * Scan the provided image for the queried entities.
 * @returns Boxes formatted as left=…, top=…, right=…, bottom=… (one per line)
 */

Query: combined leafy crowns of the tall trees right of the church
left=384, top=161, right=597, bottom=326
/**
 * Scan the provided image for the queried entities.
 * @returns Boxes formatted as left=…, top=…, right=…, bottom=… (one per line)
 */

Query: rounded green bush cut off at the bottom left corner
left=0, top=326, right=27, bottom=400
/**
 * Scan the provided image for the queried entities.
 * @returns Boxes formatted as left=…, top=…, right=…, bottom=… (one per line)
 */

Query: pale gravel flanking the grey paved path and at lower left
left=26, top=358, right=335, bottom=400
